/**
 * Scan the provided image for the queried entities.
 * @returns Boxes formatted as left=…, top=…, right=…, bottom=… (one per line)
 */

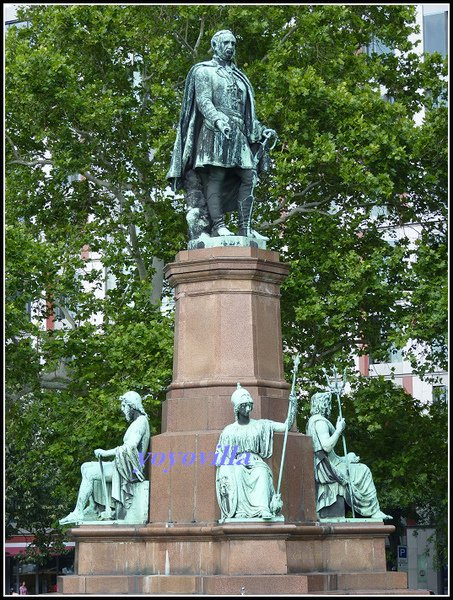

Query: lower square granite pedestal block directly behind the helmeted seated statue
left=150, top=431, right=316, bottom=524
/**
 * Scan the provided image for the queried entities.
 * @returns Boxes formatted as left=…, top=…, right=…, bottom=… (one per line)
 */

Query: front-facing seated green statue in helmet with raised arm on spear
left=216, top=383, right=297, bottom=523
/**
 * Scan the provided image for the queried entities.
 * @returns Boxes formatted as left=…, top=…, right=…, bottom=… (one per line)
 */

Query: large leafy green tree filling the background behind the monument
left=6, top=5, right=447, bottom=568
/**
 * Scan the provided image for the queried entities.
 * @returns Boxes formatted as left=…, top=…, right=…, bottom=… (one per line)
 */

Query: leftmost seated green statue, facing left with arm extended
left=60, top=392, right=150, bottom=525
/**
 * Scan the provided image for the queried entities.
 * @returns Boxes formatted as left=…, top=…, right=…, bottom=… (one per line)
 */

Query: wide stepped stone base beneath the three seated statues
left=58, top=522, right=428, bottom=595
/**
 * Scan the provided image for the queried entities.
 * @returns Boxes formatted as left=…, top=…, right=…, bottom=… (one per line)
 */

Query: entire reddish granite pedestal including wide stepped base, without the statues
left=59, top=246, right=420, bottom=595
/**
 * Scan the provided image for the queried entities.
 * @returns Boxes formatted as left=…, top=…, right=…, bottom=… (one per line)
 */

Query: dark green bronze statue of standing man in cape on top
left=167, top=30, right=276, bottom=239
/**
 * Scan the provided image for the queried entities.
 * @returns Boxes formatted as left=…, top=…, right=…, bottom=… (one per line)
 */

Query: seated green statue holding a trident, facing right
left=307, top=392, right=392, bottom=519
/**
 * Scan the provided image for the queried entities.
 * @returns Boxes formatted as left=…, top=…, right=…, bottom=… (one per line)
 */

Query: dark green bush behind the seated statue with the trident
left=343, top=377, right=447, bottom=514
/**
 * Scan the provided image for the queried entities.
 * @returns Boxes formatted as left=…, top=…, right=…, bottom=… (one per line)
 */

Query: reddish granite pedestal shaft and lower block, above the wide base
left=150, top=247, right=316, bottom=524
